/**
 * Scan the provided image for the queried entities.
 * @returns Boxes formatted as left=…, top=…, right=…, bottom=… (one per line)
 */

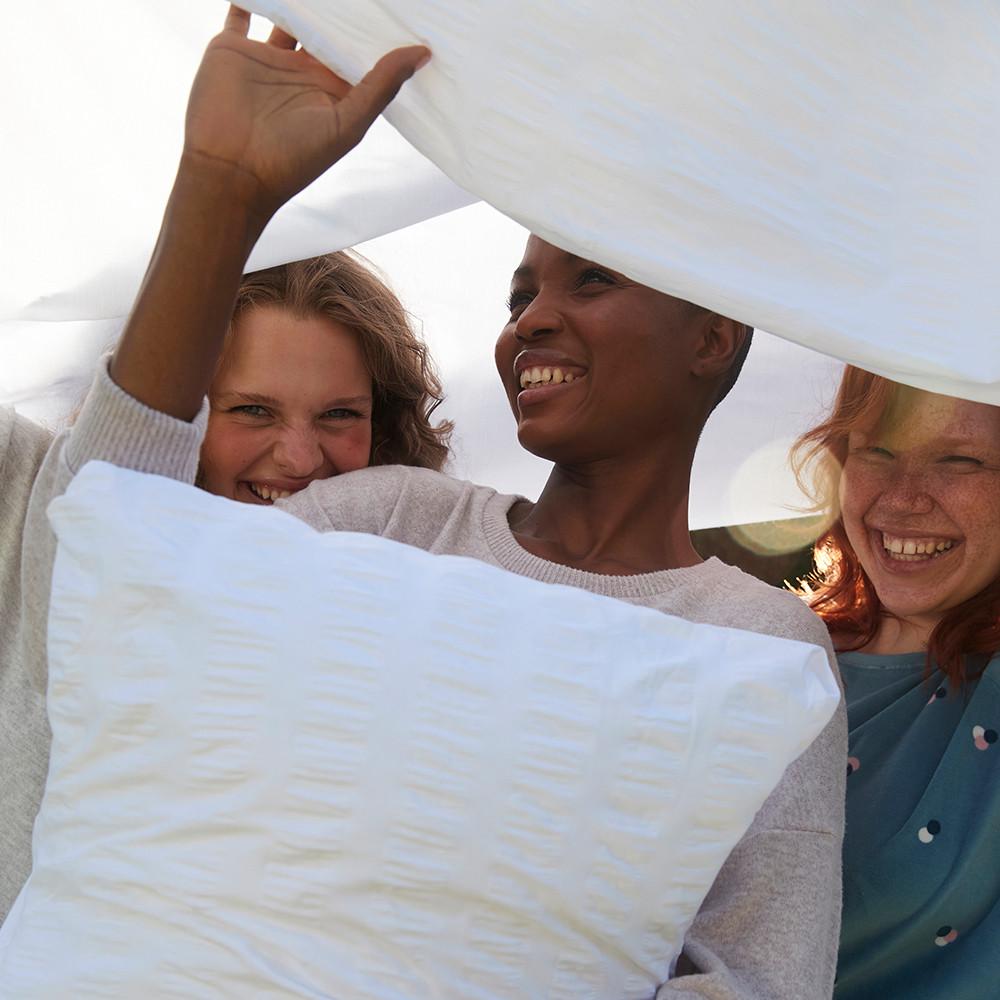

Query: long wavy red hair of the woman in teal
left=791, top=365, right=1000, bottom=684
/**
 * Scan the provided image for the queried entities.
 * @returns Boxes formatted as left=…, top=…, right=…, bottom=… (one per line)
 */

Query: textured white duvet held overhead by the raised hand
left=249, top=0, right=1000, bottom=402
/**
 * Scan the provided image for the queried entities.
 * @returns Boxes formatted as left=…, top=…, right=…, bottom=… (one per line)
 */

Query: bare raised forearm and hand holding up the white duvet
left=110, top=7, right=430, bottom=420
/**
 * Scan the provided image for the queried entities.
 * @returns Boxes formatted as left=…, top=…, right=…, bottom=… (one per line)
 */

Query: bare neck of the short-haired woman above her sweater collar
left=510, top=448, right=702, bottom=575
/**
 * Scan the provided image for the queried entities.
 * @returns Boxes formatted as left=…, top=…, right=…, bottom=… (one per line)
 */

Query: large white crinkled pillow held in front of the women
left=0, top=463, right=837, bottom=1000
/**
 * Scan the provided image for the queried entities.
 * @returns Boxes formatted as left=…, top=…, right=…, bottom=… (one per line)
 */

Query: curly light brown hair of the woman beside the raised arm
left=229, top=250, right=452, bottom=471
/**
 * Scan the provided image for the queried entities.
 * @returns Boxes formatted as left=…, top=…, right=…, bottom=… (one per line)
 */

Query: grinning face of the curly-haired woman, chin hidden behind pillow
left=199, top=306, right=372, bottom=504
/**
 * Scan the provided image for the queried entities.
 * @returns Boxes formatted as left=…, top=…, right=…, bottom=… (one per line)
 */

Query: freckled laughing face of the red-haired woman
left=840, top=389, right=1000, bottom=634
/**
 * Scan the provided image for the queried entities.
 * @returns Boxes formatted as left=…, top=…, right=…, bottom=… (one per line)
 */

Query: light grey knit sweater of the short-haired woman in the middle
left=0, top=371, right=846, bottom=1000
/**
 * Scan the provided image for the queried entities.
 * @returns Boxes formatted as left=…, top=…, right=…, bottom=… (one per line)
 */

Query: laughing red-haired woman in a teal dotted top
left=794, top=368, right=1000, bottom=1000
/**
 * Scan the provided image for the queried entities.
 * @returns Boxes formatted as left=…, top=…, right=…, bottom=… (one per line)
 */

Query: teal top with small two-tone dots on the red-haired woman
left=834, top=653, right=1000, bottom=1000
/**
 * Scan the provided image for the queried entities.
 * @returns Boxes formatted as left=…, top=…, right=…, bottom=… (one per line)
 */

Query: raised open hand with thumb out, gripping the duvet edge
left=184, top=6, right=430, bottom=225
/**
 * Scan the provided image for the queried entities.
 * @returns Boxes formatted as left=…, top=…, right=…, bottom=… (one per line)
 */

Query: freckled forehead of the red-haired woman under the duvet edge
left=876, top=386, right=1000, bottom=450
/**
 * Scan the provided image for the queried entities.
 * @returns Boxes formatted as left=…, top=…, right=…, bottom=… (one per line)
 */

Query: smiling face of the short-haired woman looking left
left=496, top=236, right=709, bottom=464
